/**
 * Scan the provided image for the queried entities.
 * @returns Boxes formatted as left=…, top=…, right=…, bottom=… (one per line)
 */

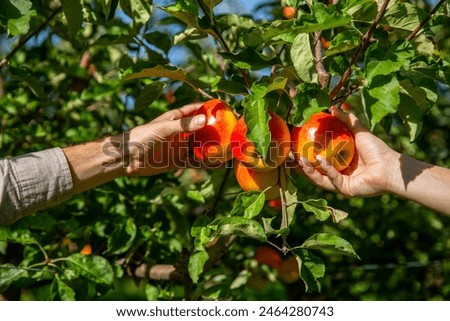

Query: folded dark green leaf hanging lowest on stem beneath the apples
left=294, top=250, right=325, bottom=293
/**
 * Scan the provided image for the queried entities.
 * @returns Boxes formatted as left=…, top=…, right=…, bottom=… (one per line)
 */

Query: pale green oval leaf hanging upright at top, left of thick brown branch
left=291, top=33, right=317, bottom=82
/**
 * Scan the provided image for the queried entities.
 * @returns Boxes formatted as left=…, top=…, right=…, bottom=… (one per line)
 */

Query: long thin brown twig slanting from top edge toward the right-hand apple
left=329, top=0, right=390, bottom=100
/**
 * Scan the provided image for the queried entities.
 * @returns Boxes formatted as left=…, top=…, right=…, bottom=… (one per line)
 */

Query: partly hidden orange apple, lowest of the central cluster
left=234, top=160, right=280, bottom=201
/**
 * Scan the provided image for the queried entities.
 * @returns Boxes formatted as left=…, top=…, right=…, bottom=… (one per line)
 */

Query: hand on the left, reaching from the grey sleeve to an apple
left=124, top=103, right=206, bottom=176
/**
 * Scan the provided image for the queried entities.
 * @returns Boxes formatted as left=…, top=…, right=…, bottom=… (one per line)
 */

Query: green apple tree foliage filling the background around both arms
left=0, top=0, right=450, bottom=300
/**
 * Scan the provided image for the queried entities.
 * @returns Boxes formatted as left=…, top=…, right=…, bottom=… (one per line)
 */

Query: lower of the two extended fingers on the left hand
left=154, top=114, right=206, bottom=139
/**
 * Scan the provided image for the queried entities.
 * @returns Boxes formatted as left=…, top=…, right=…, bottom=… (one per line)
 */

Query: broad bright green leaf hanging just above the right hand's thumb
left=362, top=75, right=400, bottom=129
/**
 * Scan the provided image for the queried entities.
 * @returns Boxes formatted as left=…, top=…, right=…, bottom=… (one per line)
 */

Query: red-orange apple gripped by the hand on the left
left=189, top=99, right=237, bottom=166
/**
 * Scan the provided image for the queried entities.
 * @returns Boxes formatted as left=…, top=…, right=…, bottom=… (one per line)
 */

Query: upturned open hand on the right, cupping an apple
left=299, top=107, right=399, bottom=197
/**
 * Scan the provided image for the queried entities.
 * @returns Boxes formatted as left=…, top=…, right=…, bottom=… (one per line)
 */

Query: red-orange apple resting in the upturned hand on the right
left=291, top=112, right=355, bottom=172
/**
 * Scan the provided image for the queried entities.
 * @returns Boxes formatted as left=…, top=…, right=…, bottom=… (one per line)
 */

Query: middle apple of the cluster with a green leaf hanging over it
left=231, top=112, right=291, bottom=171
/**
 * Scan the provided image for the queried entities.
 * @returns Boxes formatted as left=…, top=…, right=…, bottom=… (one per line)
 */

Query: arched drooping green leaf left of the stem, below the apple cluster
left=214, top=216, right=267, bottom=242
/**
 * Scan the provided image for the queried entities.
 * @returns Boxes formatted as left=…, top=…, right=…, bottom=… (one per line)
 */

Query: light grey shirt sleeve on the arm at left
left=0, top=148, right=73, bottom=226
